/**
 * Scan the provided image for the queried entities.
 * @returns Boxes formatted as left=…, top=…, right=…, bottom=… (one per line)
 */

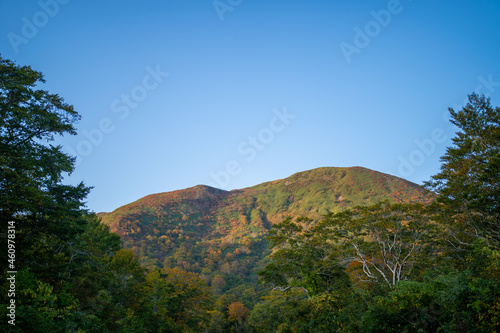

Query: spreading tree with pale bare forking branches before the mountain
left=322, top=202, right=438, bottom=288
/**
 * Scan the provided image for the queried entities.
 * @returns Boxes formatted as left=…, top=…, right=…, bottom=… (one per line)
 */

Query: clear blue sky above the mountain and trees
left=0, top=0, right=500, bottom=212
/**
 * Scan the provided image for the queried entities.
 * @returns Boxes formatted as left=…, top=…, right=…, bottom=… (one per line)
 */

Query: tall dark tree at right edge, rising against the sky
left=426, top=93, right=500, bottom=248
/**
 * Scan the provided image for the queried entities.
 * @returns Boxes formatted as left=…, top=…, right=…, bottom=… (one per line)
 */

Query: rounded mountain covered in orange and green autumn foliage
left=100, top=167, right=431, bottom=292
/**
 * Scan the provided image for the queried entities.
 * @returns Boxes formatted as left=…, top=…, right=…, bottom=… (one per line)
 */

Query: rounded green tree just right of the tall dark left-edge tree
left=64, top=214, right=145, bottom=331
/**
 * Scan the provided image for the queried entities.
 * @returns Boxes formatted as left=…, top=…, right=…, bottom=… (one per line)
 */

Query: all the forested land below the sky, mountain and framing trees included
left=0, top=58, right=500, bottom=332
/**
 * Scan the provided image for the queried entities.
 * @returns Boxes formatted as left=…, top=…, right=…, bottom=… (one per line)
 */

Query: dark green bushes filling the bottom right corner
left=362, top=241, right=500, bottom=332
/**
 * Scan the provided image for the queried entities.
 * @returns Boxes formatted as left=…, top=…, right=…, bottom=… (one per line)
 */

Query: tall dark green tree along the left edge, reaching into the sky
left=0, top=57, right=89, bottom=332
